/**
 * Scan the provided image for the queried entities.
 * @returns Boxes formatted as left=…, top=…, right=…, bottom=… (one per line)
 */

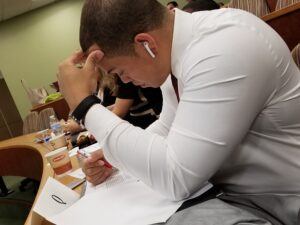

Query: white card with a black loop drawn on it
left=33, top=177, right=80, bottom=219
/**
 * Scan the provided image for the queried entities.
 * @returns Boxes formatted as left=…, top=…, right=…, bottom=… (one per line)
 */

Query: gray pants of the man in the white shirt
left=158, top=194, right=300, bottom=225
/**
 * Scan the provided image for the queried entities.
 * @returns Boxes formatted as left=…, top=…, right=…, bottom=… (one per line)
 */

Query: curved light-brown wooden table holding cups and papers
left=0, top=134, right=82, bottom=225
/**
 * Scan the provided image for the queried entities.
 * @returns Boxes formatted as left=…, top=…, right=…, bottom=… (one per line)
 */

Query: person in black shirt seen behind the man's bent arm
left=62, top=74, right=162, bottom=133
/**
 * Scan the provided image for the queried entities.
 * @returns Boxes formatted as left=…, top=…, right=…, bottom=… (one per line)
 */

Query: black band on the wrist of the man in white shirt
left=71, top=95, right=101, bottom=125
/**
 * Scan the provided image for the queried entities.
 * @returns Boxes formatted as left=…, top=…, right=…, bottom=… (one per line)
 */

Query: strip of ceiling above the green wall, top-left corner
left=0, top=0, right=59, bottom=22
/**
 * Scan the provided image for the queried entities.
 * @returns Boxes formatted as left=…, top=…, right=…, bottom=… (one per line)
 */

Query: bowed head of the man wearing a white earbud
left=80, top=0, right=173, bottom=86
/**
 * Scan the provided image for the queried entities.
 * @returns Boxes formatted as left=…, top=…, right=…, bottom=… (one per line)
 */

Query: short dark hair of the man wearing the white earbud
left=80, top=0, right=167, bottom=56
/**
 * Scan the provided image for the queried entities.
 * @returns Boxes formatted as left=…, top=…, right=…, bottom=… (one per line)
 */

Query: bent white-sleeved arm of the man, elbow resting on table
left=86, top=28, right=277, bottom=200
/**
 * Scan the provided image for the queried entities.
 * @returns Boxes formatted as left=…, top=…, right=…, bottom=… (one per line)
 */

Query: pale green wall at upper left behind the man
left=0, top=0, right=83, bottom=118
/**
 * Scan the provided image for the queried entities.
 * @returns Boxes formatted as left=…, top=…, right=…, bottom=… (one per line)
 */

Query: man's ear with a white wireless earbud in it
left=134, top=33, right=158, bottom=58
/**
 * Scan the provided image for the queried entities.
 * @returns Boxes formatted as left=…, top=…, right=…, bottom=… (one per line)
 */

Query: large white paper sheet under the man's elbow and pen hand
left=49, top=173, right=182, bottom=225
